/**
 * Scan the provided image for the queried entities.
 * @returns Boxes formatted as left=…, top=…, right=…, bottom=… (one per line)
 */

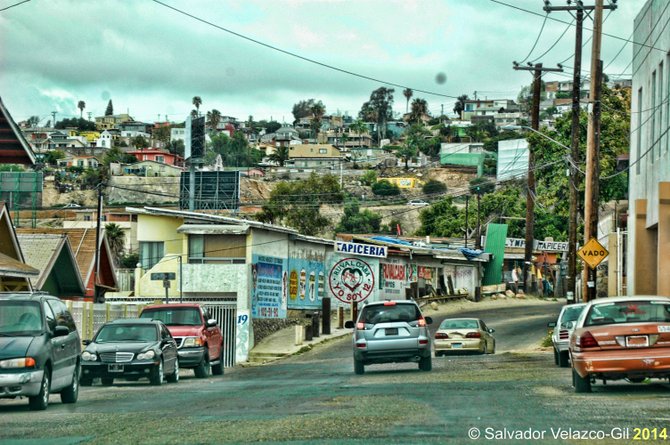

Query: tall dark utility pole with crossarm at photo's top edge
left=543, top=0, right=617, bottom=306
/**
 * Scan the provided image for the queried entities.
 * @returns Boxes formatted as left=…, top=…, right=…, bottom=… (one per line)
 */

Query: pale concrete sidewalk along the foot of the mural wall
left=241, top=326, right=352, bottom=366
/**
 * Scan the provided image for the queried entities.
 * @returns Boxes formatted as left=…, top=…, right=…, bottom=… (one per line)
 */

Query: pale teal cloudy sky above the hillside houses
left=0, top=0, right=645, bottom=125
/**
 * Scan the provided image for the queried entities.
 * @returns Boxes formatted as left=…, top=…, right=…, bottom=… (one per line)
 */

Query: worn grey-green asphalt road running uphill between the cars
left=0, top=298, right=670, bottom=445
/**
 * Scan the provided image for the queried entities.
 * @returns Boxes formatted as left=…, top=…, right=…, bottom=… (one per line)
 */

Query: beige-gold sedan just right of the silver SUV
left=434, top=318, right=496, bottom=357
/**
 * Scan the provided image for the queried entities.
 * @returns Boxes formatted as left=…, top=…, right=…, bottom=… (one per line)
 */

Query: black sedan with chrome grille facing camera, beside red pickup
left=81, top=318, right=179, bottom=386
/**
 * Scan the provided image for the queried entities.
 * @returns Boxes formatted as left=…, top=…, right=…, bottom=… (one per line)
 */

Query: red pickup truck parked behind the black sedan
left=140, top=303, right=223, bottom=378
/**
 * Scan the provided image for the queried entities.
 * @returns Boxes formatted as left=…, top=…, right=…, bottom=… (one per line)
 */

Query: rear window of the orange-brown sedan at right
left=584, top=300, right=670, bottom=326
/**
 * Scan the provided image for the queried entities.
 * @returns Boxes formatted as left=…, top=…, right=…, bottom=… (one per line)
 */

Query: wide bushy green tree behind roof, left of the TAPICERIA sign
left=257, top=173, right=344, bottom=235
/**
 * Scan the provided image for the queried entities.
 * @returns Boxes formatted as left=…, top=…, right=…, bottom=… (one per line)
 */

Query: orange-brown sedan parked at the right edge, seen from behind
left=569, top=296, right=670, bottom=392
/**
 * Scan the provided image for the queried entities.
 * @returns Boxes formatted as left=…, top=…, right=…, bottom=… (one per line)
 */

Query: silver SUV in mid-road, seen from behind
left=345, top=300, right=433, bottom=374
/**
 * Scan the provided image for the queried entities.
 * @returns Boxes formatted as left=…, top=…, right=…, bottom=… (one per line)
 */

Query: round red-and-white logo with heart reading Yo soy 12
left=328, top=258, right=375, bottom=303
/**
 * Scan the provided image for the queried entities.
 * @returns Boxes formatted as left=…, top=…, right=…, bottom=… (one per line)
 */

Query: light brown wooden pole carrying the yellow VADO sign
left=582, top=0, right=603, bottom=302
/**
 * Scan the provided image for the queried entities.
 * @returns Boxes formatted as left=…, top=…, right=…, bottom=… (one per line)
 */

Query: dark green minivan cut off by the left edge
left=0, top=293, right=81, bottom=410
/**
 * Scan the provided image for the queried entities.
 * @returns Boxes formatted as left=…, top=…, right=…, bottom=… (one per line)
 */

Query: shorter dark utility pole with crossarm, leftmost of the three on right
left=513, top=62, right=563, bottom=293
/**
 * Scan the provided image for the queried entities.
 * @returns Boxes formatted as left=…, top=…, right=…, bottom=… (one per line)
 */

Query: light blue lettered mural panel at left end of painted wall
left=251, top=255, right=289, bottom=318
